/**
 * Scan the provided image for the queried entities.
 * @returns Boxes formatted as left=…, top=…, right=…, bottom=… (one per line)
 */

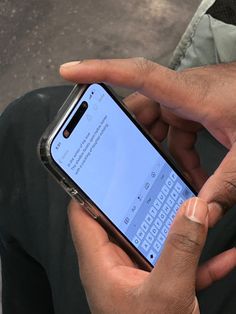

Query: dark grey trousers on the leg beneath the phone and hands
left=0, top=86, right=236, bottom=314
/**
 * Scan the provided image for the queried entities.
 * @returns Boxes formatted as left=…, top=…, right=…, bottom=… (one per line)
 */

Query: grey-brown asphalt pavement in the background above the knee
left=0, top=0, right=200, bottom=112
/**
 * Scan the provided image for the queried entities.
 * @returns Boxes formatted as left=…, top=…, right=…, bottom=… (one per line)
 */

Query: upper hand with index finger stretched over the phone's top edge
left=60, top=58, right=236, bottom=226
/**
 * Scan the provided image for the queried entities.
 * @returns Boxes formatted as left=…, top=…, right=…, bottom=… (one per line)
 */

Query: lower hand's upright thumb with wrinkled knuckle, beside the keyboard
left=153, top=197, right=208, bottom=295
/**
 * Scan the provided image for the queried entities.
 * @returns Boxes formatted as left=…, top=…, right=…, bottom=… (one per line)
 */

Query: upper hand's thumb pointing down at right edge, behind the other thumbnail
left=199, top=144, right=236, bottom=227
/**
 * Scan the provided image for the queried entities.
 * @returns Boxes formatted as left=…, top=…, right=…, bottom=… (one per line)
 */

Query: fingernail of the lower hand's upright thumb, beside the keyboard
left=185, top=197, right=208, bottom=225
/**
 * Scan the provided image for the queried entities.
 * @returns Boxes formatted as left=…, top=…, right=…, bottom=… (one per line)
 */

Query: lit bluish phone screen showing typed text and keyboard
left=51, top=84, right=195, bottom=266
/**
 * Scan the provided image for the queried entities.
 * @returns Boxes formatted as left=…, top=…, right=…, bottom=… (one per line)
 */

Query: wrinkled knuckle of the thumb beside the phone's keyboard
left=169, top=232, right=201, bottom=255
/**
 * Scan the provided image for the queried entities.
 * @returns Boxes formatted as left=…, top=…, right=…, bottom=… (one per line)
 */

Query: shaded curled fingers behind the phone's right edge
left=123, top=92, right=208, bottom=191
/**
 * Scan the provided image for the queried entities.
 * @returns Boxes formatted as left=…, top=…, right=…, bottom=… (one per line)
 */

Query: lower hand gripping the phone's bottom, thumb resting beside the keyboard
left=69, top=198, right=236, bottom=314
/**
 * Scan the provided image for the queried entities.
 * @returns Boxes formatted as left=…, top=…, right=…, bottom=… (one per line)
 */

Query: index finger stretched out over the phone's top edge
left=60, top=58, right=204, bottom=121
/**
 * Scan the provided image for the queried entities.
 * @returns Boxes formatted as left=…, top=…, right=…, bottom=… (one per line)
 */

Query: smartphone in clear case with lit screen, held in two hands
left=39, top=84, right=196, bottom=270
